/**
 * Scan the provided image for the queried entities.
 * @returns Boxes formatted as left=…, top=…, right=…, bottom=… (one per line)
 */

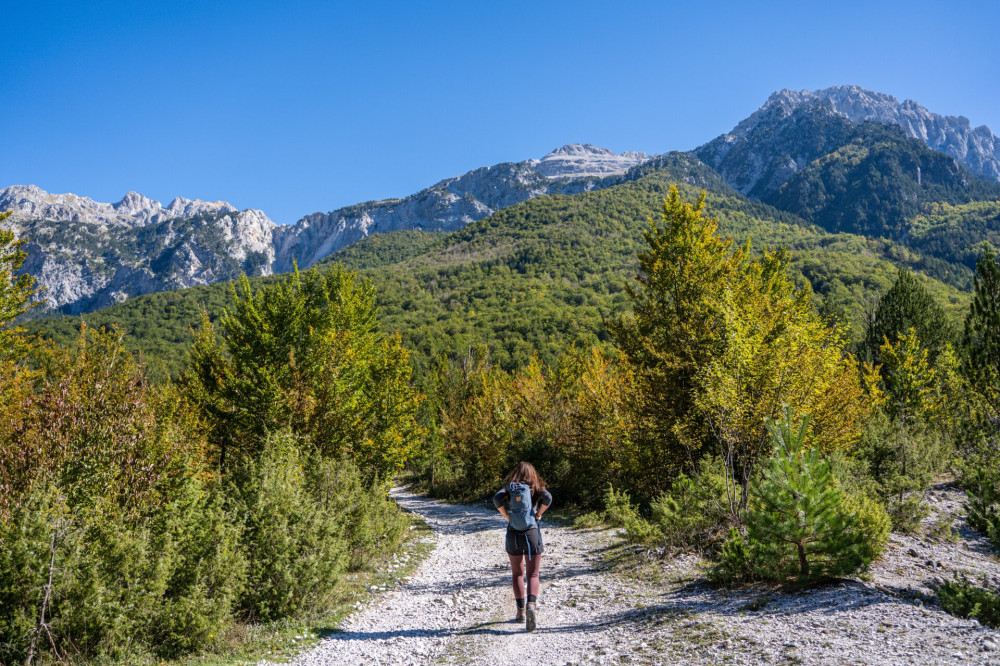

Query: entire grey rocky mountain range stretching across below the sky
left=0, top=86, right=1000, bottom=314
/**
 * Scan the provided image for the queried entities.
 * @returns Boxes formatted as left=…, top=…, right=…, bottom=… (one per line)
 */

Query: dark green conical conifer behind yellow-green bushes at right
left=861, top=268, right=953, bottom=365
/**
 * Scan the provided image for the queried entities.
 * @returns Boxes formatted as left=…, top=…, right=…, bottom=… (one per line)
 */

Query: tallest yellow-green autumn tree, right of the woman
left=611, top=187, right=864, bottom=506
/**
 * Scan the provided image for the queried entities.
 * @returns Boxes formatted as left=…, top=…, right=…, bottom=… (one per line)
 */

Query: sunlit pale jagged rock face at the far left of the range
left=6, top=186, right=277, bottom=314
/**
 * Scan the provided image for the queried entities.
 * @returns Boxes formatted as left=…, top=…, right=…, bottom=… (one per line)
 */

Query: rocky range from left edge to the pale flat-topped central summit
left=0, top=145, right=648, bottom=314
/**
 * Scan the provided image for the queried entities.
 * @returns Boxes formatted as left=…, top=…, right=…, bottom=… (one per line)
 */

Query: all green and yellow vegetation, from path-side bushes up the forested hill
left=0, top=174, right=1000, bottom=663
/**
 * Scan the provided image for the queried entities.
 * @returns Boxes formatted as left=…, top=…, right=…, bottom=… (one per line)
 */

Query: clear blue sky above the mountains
left=0, top=0, right=1000, bottom=222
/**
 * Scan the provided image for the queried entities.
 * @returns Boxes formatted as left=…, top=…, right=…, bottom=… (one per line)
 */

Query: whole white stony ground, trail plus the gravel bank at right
left=280, top=488, right=1000, bottom=666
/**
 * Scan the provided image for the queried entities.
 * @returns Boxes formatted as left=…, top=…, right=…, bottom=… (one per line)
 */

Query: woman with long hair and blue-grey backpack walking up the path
left=493, top=462, right=552, bottom=631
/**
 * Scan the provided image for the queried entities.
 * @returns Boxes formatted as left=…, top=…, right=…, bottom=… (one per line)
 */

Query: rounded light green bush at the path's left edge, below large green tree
left=229, top=432, right=408, bottom=621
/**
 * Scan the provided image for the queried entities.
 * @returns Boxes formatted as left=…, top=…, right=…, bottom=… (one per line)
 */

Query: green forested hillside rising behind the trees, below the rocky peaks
left=31, top=166, right=972, bottom=378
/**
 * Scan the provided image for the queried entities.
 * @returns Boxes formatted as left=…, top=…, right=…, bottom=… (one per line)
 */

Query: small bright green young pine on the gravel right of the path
left=746, top=406, right=871, bottom=582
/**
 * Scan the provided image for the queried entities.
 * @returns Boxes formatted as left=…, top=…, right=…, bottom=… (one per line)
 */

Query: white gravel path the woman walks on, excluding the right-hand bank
left=282, top=489, right=630, bottom=665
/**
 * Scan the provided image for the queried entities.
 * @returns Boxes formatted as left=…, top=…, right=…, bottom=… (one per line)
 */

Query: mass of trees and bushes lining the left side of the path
left=0, top=209, right=422, bottom=663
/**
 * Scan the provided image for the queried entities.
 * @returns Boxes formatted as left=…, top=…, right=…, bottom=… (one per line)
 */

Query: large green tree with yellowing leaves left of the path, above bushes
left=182, top=268, right=423, bottom=479
